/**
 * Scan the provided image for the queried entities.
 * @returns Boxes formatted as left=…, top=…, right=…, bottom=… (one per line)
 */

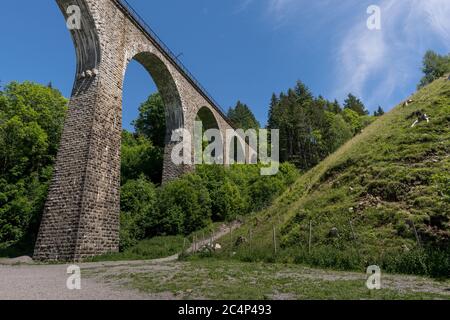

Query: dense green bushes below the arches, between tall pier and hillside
left=120, top=163, right=298, bottom=249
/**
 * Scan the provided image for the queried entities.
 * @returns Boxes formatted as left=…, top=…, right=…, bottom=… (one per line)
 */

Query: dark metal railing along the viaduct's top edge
left=115, top=0, right=226, bottom=116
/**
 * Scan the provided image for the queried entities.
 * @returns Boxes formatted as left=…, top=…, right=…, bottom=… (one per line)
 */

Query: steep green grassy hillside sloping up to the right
left=216, top=78, right=450, bottom=276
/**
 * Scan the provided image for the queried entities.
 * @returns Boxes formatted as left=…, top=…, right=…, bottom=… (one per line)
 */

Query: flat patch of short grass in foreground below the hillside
left=96, top=259, right=450, bottom=300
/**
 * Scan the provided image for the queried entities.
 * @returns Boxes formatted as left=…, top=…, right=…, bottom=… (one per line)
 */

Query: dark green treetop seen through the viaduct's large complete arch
left=133, top=93, right=166, bottom=148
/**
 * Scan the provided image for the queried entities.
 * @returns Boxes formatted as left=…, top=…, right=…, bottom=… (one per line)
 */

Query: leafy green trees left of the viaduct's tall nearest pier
left=0, top=82, right=67, bottom=245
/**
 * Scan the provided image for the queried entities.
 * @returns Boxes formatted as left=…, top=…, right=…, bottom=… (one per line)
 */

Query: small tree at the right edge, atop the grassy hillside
left=418, top=50, right=450, bottom=89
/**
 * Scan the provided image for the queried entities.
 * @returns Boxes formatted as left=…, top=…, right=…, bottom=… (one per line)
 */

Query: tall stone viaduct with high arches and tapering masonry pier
left=34, top=0, right=244, bottom=261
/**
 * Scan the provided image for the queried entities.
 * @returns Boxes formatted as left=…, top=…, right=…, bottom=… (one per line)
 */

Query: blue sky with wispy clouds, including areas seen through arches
left=0, top=0, right=450, bottom=128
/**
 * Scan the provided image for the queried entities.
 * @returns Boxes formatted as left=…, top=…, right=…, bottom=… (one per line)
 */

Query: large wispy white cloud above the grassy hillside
left=335, top=0, right=450, bottom=107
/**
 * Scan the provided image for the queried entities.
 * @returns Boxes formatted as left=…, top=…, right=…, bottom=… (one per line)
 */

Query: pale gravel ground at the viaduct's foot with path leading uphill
left=0, top=222, right=240, bottom=300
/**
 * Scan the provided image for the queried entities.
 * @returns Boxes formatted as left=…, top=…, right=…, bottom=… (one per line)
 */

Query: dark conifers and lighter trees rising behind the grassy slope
left=268, top=81, right=373, bottom=170
